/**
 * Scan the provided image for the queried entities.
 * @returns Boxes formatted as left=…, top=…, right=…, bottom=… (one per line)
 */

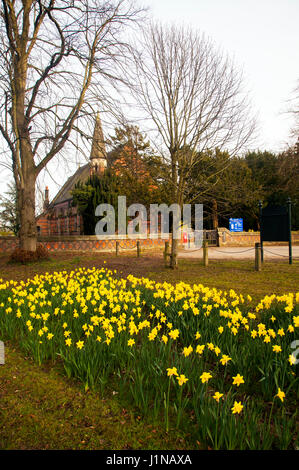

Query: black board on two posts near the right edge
left=259, top=198, right=293, bottom=264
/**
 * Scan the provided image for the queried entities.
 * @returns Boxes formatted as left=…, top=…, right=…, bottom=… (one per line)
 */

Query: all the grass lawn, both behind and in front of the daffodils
left=0, top=253, right=299, bottom=450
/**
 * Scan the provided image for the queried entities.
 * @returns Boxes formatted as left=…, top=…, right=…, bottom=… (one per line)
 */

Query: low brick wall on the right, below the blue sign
left=218, top=228, right=299, bottom=246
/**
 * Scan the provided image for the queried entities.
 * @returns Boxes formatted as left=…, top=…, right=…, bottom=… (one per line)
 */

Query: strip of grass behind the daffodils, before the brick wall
left=0, top=252, right=299, bottom=301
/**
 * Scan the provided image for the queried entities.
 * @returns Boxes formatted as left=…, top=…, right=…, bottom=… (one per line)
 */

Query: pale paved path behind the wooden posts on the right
left=178, top=245, right=299, bottom=260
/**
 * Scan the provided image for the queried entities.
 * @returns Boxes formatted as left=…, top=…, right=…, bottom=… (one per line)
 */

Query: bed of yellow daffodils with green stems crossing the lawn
left=0, top=268, right=299, bottom=449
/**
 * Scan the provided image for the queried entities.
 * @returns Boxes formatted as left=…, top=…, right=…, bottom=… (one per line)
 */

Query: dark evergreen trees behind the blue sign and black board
left=188, top=146, right=299, bottom=230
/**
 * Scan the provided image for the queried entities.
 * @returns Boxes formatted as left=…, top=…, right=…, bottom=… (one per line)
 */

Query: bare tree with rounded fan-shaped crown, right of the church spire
left=134, top=24, right=255, bottom=267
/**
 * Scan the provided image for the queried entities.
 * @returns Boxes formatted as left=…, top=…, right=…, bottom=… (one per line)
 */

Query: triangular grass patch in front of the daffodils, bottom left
left=0, top=344, right=191, bottom=450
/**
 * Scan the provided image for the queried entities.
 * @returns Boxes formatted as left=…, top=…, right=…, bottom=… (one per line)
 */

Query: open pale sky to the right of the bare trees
left=148, top=0, right=299, bottom=152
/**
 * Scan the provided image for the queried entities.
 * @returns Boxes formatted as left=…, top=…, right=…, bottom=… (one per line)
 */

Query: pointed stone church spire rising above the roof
left=90, top=112, right=107, bottom=174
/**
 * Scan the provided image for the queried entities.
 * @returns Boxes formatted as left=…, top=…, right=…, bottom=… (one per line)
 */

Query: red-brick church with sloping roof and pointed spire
left=36, top=113, right=107, bottom=236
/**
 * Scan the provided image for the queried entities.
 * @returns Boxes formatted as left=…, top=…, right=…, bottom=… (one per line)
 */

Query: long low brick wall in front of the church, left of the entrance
left=0, top=236, right=166, bottom=253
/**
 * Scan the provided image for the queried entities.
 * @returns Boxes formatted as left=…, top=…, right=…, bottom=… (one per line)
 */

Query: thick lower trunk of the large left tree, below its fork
left=19, top=174, right=37, bottom=251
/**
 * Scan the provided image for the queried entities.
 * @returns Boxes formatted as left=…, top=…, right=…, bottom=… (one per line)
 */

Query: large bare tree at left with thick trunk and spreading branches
left=0, top=0, right=141, bottom=251
